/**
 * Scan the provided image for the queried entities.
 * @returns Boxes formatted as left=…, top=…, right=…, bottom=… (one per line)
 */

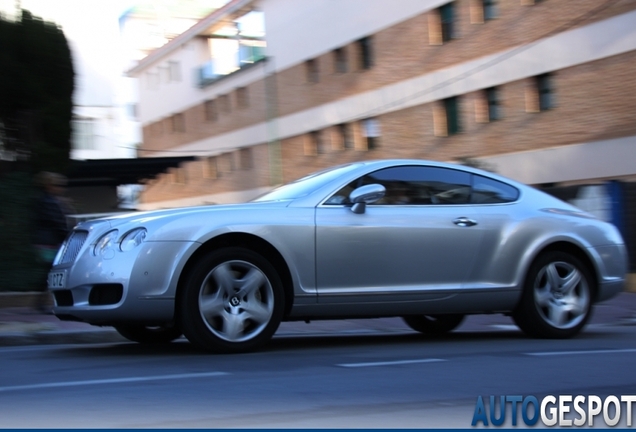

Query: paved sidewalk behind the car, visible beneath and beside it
left=0, top=292, right=636, bottom=347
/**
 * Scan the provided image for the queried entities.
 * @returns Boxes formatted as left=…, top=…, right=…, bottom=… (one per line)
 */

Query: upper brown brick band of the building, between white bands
left=141, top=0, right=636, bottom=156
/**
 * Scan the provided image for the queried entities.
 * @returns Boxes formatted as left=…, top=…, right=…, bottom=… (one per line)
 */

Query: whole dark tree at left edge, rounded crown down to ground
left=0, top=10, right=75, bottom=291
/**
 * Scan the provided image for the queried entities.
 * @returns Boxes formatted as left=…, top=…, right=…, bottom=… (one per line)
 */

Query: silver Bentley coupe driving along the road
left=48, top=160, right=627, bottom=353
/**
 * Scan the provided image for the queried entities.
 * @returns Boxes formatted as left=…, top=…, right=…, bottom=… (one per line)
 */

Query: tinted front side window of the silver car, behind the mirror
left=326, top=166, right=471, bottom=205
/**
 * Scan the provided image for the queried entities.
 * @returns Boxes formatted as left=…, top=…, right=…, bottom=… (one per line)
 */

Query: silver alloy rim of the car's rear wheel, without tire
left=534, top=261, right=591, bottom=329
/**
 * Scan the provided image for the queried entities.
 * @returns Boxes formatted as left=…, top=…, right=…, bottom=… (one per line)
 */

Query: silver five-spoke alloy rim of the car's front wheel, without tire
left=199, top=260, right=274, bottom=342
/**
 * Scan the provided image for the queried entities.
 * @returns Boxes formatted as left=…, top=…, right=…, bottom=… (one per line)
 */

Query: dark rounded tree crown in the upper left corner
left=0, top=10, right=75, bottom=172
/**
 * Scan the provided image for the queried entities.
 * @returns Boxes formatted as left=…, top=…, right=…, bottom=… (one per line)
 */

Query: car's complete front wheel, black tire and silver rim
left=179, top=247, right=285, bottom=353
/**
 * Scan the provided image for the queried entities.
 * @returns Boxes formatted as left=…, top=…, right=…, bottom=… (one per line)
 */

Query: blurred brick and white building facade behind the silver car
left=129, top=0, right=636, bottom=209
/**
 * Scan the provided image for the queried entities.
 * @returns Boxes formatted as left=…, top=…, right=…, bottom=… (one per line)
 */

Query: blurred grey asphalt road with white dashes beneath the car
left=0, top=323, right=636, bottom=428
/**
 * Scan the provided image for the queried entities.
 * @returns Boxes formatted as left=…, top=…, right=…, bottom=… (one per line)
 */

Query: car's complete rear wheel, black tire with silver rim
left=512, top=251, right=594, bottom=339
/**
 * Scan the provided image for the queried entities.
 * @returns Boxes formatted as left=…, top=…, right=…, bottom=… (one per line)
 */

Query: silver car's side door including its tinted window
left=316, top=166, right=483, bottom=303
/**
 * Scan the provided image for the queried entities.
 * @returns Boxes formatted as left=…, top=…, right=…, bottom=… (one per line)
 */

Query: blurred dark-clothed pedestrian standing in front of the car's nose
left=33, top=171, right=70, bottom=313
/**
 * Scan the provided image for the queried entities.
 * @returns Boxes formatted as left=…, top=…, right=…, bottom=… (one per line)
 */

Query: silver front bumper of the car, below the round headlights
left=49, top=241, right=196, bottom=325
